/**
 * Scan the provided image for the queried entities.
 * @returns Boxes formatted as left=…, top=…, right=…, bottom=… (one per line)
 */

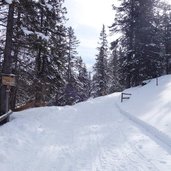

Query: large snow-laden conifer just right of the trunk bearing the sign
left=1, top=0, right=67, bottom=109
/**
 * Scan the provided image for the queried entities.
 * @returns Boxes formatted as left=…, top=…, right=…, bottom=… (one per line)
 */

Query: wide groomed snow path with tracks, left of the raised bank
left=0, top=94, right=171, bottom=171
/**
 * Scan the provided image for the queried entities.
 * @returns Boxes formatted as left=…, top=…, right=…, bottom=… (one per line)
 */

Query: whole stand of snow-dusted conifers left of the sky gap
left=0, top=0, right=90, bottom=112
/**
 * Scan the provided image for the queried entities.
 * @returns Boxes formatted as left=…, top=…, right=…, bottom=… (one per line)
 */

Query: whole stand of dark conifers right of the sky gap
left=92, top=0, right=171, bottom=97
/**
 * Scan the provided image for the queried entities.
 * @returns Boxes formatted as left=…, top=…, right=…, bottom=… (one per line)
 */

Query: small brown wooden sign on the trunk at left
left=2, top=74, right=16, bottom=86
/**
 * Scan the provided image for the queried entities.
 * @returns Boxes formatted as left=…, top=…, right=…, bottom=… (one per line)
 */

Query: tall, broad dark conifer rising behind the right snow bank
left=111, top=0, right=162, bottom=87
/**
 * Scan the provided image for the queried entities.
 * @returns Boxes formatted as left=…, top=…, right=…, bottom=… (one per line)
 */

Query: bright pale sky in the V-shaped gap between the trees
left=65, top=0, right=116, bottom=70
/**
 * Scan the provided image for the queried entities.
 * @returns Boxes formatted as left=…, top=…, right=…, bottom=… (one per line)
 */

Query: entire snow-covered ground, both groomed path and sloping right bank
left=0, top=76, right=171, bottom=171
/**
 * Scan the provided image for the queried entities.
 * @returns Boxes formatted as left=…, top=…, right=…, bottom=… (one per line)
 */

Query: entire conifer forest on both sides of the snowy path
left=0, top=0, right=171, bottom=113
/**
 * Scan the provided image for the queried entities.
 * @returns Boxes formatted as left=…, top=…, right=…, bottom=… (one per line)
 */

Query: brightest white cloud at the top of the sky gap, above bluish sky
left=71, top=0, right=114, bottom=28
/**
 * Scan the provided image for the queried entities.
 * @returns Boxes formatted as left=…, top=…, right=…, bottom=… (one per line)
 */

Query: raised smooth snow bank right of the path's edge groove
left=119, top=75, right=171, bottom=137
